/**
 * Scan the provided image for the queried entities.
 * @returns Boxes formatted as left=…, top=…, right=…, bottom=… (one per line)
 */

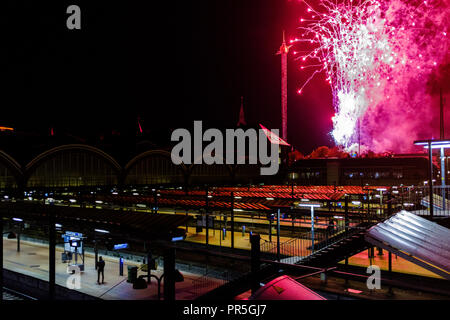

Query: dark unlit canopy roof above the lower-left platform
left=0, top=202, right=190, bottom=240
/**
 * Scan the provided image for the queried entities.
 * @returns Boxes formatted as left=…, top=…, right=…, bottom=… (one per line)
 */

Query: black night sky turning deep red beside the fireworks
left=0, top=0, right=334, bottom=153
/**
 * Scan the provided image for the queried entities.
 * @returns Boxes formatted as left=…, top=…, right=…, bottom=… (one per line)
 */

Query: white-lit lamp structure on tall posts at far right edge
left=414, top=140, right=450, bottom=219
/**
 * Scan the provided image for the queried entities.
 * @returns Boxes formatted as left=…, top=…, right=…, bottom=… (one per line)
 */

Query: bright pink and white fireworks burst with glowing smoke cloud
left=291, top=0, right=449, bottom=152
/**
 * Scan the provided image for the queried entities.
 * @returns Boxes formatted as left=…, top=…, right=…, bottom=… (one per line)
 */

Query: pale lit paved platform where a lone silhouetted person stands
left=3, top=238, right=223, bottom=300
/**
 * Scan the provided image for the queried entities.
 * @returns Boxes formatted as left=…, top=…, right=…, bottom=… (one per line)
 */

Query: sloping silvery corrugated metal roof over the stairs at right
left=365, top=211, right=450, bottom=280
